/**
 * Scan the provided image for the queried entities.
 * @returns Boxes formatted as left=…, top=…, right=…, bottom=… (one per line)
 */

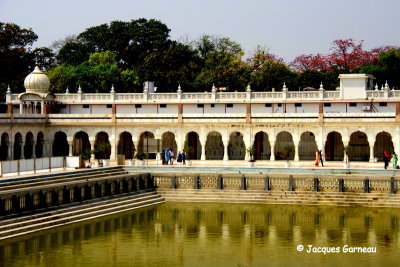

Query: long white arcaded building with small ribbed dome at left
left=0, top=68, right=400, bottom=164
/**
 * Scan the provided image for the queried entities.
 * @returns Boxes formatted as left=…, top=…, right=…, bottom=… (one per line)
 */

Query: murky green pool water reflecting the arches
left=0, top=203, right=400, bottom=267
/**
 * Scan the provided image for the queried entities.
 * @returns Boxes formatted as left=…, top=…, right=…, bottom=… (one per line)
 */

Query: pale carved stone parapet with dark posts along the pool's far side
left=154, top=174, right=400, bottom=194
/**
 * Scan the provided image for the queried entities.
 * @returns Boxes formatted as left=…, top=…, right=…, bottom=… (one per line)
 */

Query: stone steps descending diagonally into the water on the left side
left=0, top=191, right=165, bottom=240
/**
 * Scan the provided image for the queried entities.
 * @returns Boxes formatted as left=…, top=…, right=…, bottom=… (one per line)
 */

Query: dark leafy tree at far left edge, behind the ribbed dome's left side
left=0, top=22, right=38, bottom=92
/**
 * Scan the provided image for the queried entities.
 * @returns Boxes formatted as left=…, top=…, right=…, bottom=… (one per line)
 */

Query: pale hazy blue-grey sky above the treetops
left=0, top=0, right=400, bottom=61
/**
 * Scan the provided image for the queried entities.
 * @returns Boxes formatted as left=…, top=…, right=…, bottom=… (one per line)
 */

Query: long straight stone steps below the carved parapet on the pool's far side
left=157, top=188, right=400, bottom=208
